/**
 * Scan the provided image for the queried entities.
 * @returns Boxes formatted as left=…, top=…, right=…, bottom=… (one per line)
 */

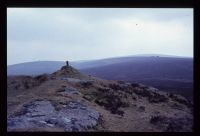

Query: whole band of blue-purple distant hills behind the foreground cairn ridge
left=7, top=54, right=193, bottom=99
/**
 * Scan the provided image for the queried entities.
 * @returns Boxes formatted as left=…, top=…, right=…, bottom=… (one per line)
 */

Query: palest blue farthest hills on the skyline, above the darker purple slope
left=7, top=54, right=192, bottom=75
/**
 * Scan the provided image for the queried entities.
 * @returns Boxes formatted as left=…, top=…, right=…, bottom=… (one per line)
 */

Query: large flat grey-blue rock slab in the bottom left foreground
left=7, top=101, right=100, bottom=131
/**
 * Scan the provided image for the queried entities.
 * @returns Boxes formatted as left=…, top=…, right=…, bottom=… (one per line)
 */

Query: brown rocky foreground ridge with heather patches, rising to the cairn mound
left=7, top=66, right=193, bottom=132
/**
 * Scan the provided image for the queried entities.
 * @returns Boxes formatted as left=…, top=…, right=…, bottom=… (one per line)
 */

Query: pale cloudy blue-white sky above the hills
left=7, top=8, right=193, bottom=65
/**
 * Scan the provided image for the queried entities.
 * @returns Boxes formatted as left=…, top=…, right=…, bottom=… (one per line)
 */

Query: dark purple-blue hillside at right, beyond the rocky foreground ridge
left=81, top=57, right=193, bottom=99
